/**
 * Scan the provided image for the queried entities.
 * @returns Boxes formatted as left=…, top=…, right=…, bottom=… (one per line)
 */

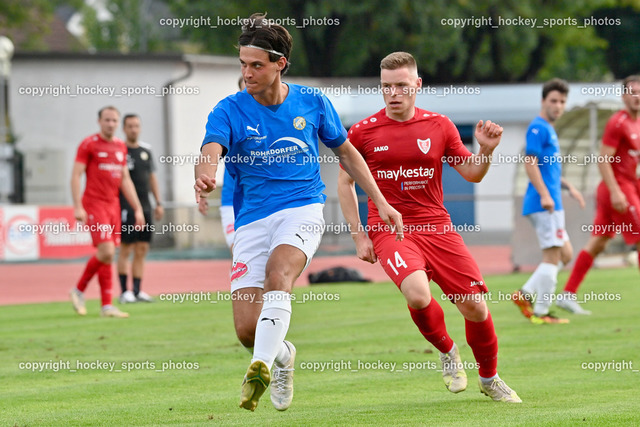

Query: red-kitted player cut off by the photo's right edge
left=558, top=75, right=640, bottom=311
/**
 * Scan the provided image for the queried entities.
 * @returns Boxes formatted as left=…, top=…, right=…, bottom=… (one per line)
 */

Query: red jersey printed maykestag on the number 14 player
left=349, top=108, right=471, bottom=233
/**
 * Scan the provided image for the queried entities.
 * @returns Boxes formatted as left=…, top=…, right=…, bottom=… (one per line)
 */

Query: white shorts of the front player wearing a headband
left=231, top=203, right=324, bottom=292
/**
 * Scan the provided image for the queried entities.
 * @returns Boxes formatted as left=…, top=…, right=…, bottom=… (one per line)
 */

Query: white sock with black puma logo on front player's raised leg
left=251, top=291, right=291, bottom=369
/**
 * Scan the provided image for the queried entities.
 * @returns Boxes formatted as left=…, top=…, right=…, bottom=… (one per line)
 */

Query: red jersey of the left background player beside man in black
left=76, top=134, right=127, bottom=203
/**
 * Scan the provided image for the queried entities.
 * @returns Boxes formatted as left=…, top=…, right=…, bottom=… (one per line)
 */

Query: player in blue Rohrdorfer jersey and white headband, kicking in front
left=194, top=14, right=402, bottom=411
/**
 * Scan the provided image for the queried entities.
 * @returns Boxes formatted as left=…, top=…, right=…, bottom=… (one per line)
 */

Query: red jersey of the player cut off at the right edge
left=602, top=110, right=640, bottom=183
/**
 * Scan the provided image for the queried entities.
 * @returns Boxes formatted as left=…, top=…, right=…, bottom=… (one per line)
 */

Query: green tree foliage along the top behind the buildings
left=0, top=0, right=640, bottom=84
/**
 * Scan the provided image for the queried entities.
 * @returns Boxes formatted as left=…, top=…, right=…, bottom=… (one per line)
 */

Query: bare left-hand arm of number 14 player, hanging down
left=338, top=169, right=378, bottom=264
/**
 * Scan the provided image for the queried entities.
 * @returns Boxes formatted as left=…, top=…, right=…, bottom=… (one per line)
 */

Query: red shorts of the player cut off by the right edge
left=591, top=182, right=640, bottom=245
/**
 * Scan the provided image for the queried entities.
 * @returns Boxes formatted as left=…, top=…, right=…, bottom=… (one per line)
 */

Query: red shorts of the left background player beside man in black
left=82, top=200, right=121, bottom=246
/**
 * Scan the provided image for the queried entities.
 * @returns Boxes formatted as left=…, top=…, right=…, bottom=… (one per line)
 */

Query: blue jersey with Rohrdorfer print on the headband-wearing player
left=202, top=84, right=347, bottom=228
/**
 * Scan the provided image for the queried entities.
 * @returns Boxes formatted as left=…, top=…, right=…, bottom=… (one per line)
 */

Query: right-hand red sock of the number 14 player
left=464, top=313, right=498, bottom=378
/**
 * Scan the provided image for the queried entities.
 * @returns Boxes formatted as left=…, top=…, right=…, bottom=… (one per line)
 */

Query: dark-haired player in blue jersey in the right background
left=513, top=78, right=584, bottom=324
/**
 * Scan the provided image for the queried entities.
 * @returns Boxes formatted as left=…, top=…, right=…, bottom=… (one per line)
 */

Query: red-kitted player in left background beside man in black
left=71, top=106, right=145, bottom=317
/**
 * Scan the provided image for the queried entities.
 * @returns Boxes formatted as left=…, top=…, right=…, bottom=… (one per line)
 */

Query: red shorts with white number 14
left=371, top=231, right=489, bottom=302
